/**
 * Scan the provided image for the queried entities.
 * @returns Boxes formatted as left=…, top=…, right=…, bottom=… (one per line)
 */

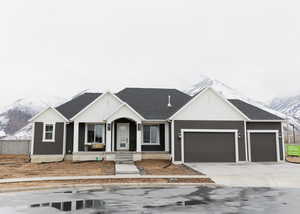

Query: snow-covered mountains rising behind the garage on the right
left=185, top=75, right=300, bottom=130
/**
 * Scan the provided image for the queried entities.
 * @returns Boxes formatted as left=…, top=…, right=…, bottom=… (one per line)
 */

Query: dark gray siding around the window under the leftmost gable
left=33, top=123, right=64, bottom=155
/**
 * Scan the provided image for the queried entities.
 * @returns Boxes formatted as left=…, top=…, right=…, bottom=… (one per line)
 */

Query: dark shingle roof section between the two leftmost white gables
left=56, top=93, right=101, bottom=119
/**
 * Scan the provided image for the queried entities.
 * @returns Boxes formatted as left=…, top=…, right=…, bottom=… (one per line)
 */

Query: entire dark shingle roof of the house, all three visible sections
left=56, top=88, right=283, bottom=120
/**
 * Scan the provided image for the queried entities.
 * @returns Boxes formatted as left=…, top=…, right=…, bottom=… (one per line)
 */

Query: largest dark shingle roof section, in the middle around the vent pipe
left=116, top=88, right=192, bottom=120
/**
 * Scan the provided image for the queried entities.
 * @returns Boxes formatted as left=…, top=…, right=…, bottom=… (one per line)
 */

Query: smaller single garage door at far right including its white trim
left=248, top=130, right=280, bottom=162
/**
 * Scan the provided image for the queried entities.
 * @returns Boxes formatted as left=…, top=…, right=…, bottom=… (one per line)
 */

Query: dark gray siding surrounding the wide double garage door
left=174, top=120, right=246, bottom=161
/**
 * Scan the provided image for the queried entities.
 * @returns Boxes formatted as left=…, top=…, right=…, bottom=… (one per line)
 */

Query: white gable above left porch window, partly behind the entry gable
left=74, top=93, right=123, bottom=123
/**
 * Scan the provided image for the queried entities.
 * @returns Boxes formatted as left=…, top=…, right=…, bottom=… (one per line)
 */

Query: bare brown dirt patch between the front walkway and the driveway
left=135, top=160, right=202, bottom=175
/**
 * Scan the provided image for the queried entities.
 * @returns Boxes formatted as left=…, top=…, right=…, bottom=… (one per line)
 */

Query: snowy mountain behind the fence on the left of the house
left=0, top=97, right=64, bottom=139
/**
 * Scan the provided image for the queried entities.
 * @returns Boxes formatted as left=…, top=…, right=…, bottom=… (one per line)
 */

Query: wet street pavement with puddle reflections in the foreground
left=0, top=186, right=300, bottom=214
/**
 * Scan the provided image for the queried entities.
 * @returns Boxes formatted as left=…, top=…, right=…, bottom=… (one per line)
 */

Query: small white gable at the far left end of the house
left=30, top=107, right=66, bottom=123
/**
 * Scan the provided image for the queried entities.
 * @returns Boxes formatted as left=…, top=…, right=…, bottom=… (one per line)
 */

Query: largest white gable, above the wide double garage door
left=172, top=88, right=247, bottom=121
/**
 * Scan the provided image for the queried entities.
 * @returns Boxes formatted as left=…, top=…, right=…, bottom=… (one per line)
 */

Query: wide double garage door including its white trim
left=181, top=129, right=238, bottom=163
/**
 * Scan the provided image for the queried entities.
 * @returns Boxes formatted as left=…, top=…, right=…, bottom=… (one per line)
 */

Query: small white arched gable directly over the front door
left=107, top=104, right=143, bottom=122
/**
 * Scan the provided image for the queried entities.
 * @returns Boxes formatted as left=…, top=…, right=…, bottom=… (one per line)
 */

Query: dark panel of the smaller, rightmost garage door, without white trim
left=250, top=133, right=277, bottom=162
